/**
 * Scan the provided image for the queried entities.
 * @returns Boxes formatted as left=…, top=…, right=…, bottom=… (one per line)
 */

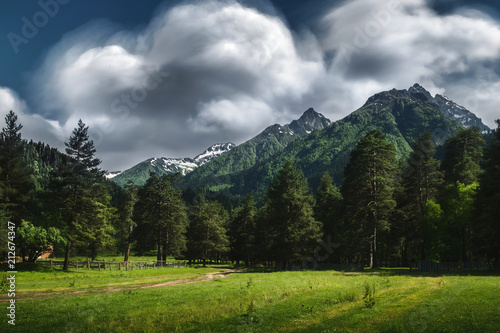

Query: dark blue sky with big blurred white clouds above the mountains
left=0, top=0, right=500, bottom=170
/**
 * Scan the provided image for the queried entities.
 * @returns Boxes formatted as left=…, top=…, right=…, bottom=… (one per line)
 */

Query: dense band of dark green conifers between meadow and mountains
left=0, top=111, right=500, bottom=269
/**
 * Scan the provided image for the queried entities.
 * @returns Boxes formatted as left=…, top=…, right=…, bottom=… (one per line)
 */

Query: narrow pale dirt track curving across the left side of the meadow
left=0, top=269, right=238, bottom=304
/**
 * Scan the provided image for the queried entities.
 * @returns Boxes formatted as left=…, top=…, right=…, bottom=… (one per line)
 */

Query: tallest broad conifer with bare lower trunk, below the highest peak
left=341, top=130, right=397, bottom=268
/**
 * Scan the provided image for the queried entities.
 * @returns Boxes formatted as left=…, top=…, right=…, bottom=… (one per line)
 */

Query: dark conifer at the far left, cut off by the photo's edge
left=0, top=111, right=34, bottom=226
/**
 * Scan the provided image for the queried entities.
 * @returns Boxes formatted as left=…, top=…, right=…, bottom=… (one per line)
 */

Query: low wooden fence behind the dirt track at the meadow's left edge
left=36, top=260, right=187, bottom=271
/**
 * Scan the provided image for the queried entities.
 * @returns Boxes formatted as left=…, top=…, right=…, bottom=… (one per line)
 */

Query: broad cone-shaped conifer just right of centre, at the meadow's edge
left=264, top=161, right=322, bottom=269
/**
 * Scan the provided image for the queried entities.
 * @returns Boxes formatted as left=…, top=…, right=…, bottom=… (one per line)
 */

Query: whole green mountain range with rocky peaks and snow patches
left=113, top=84, right=490, bottom=198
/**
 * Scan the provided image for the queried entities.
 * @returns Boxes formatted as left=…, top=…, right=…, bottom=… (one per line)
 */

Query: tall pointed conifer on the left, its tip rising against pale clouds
left=48, top=120, right=115, bottom=270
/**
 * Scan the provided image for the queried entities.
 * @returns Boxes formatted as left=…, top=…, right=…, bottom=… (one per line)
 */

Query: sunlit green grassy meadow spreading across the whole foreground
left=0, top=268, right=500, bottom=332
